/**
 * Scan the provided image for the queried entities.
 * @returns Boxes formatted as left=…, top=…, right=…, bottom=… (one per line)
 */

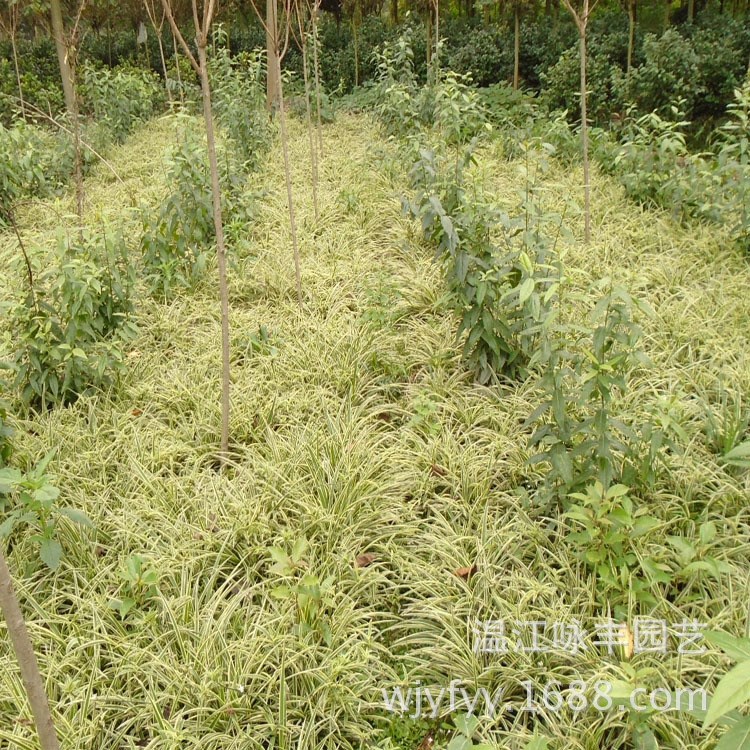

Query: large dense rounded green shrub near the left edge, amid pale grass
left=10, top=234, right=135, bottom=409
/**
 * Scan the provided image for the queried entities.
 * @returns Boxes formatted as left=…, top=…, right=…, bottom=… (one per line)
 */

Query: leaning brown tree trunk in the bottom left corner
left=0, top=549, right=60, bottom=750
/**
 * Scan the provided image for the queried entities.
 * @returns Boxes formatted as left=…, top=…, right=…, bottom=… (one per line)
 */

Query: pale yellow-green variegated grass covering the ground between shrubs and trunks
left=0, top=110, right=750, bottom=750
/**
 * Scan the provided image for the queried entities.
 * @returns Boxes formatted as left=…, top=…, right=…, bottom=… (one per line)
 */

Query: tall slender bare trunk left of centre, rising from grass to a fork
left=198, top=44, right=229, bottom=464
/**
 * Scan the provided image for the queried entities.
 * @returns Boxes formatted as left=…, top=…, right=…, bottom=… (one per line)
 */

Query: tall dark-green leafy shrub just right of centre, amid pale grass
left=405, top=140, right=558, bottom=383
